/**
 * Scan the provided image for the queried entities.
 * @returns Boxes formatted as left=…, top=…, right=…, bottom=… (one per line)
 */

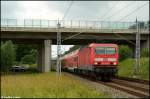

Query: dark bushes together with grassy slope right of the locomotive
left=118, top=45, right=149, bottom=80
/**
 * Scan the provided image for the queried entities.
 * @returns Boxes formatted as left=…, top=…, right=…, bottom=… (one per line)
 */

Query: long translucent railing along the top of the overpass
left=1, top=19, right=149, bottom=29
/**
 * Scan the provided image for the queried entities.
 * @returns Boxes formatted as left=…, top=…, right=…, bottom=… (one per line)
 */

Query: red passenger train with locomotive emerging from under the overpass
left=61, top=43, right=119, bottom=80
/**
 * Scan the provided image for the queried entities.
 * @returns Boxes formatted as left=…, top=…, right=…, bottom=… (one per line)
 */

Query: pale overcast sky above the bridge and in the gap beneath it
left=1, top=1, right=149, bottom=57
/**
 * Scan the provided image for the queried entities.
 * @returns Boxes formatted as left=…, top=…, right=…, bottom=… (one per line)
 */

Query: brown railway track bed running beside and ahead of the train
left=67, top=73, right=149, bottom=98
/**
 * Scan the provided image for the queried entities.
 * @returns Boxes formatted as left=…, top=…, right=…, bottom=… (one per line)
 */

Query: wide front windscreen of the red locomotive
left=95, top=47, right=116, bottom=54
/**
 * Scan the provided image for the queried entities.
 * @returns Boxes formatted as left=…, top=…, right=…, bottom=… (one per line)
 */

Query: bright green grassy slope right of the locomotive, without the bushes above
left=118, top=57, right=149, bottom=80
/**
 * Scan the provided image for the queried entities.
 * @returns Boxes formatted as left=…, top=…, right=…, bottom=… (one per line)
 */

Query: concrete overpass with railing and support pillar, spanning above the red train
left=1, top=19, right=149, bottom=72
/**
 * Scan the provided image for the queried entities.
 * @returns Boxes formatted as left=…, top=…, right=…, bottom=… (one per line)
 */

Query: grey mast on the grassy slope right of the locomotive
left=134, top=19, right=140, bottom=75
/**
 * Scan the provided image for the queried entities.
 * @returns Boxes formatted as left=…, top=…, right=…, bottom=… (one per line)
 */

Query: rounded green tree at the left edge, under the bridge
left=1, top=40, right=16, bottom=72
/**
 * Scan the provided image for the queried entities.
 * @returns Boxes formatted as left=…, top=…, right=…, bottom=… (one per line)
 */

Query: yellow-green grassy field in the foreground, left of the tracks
left=1, top=72, right=111, bottom=98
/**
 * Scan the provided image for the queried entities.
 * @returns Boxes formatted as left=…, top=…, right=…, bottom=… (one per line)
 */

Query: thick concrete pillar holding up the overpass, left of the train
left=38, top=40, right=51, bottom=72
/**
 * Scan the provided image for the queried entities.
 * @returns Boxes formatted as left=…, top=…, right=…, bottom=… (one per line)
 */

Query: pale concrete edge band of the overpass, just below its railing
left=1, top=27, right=149, bottom=34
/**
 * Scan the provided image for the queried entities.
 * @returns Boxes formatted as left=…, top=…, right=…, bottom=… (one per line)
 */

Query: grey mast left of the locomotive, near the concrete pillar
left=57, top=21, right=61, bottom=75
